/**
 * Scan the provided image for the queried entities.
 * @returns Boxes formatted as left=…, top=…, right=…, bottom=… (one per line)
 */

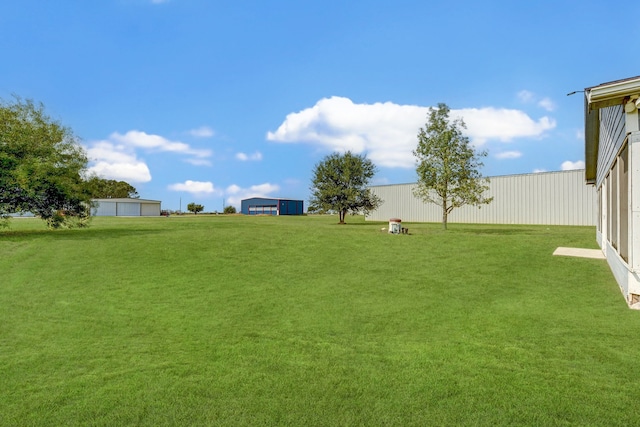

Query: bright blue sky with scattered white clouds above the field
left=0, top=0, right=640, bottom=212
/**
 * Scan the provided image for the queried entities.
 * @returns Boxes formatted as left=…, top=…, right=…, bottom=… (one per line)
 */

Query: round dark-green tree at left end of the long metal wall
left=308, top=151, right=382, bottom=224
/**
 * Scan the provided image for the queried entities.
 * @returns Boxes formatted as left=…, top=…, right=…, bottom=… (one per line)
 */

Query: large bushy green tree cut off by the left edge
left=0, top=97, right=91, bottom=228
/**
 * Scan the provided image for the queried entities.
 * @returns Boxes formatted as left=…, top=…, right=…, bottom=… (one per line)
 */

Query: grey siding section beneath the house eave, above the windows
left=596, top=105, right=626, bottom=187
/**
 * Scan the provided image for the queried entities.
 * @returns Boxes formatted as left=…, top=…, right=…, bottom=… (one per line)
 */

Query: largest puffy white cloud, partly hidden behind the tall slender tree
left=267, top=96, right=556, bottom=168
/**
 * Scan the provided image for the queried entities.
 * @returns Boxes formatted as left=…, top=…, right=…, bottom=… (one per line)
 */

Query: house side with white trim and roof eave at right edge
left=585, top=77, right=640, bottom=308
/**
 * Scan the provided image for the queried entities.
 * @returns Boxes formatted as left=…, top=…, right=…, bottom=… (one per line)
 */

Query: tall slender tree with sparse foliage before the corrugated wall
left=413, top=104, right=493, bottom=230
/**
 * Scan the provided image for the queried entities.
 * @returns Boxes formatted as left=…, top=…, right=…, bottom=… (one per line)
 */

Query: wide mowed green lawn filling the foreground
left=0, top=216, right=640, bottom=426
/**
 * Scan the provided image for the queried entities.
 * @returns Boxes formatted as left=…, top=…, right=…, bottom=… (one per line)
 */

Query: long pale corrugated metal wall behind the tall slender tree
left=366, top=170, right=597, bottom=225
